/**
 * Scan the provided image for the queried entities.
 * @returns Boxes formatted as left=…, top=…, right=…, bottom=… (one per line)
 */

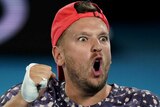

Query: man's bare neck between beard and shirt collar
left=65, top=81, right=111, bottom=106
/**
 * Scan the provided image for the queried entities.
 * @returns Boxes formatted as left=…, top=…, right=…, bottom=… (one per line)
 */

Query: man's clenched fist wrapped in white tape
left=21, top=63, right=55, bottom=102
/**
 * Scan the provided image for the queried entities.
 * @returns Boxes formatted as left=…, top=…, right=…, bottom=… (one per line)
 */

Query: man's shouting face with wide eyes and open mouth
left=62, top=17, right=111, bottom=92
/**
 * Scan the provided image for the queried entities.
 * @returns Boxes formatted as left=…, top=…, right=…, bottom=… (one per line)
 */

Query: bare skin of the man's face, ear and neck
left=53, top=17, right=111, bottom=106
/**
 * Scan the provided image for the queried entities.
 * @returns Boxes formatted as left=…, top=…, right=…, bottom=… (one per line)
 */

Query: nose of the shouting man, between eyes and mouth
left=91, top=39, right=102, bottom=52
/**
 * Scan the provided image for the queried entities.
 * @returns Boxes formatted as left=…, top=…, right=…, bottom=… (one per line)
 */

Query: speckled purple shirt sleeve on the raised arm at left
left=0, top=84, right=21, bottom=107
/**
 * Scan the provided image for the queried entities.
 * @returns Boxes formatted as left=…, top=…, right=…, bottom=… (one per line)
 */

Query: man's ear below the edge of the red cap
left=52, top=46, right=64, bottom=66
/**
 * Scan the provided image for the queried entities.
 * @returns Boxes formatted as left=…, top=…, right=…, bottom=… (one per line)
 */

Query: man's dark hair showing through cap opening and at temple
left=57, top=0, right=99, bottom=46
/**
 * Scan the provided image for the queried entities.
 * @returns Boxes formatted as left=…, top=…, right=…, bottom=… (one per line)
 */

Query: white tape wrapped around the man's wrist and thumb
left=21, top=63, right=48, bottom=102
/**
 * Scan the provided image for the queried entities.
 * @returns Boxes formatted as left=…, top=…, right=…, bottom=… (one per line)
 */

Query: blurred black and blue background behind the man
left=0, top=0, right=160, bottom=96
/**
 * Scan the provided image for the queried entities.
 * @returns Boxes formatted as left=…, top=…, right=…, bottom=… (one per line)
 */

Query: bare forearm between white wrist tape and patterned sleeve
left=3, top=92, right=28, bottom=107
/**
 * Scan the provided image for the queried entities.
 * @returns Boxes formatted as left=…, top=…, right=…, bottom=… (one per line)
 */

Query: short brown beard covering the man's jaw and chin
left=65, top=56, right=108, bottom=96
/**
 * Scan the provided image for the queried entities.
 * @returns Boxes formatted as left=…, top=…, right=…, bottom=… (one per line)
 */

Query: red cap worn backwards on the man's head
left=51, top=1, right=109, bottom=81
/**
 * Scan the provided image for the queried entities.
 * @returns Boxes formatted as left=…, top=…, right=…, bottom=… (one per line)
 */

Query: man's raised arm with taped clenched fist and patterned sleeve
left=0, top=64, right=55, bottom=107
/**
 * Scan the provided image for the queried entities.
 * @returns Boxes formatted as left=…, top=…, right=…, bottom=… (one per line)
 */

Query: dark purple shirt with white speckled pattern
left=0, top=79, right=160, bottom=107
